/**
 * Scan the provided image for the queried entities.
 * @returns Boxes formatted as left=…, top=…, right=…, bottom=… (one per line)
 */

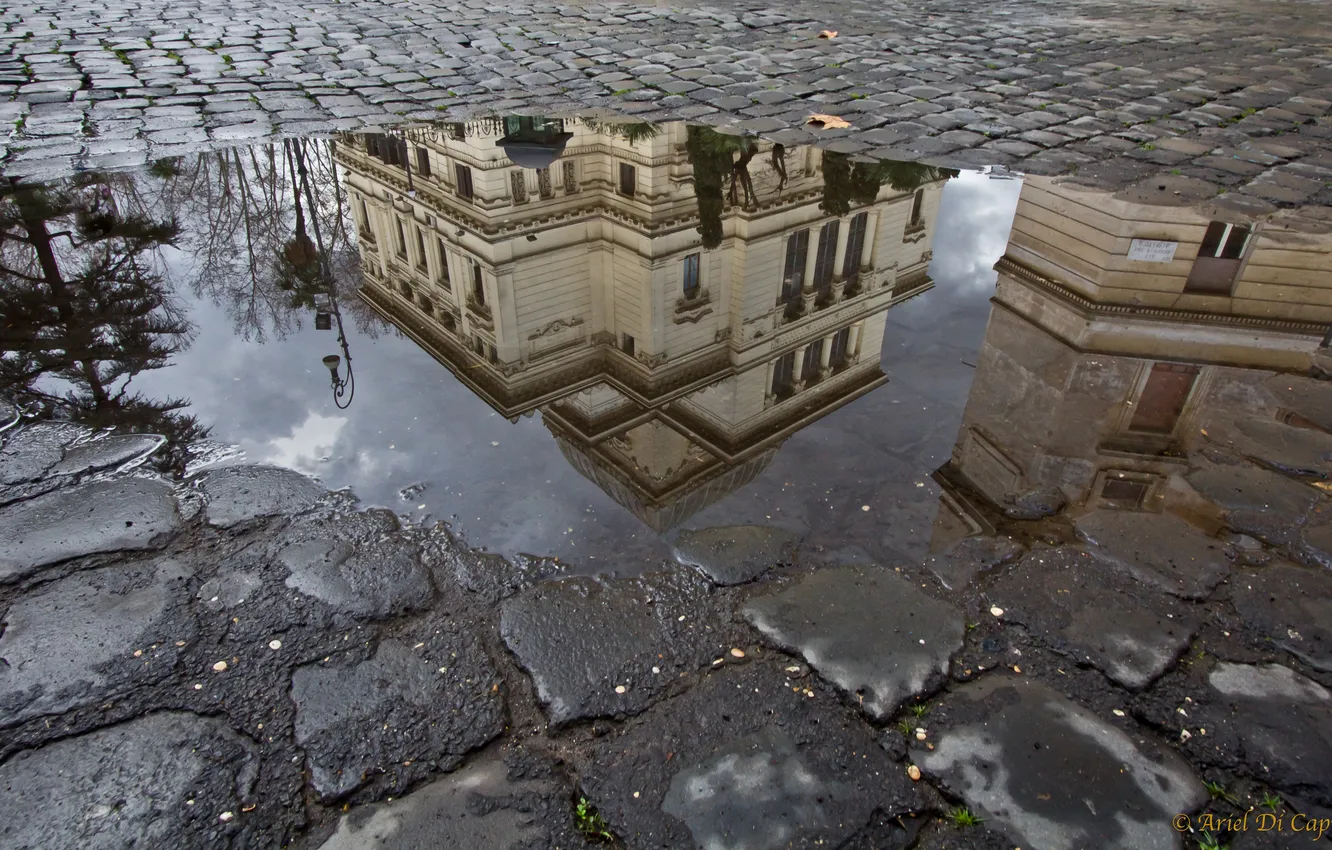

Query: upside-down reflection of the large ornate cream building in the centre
left=337, top=117, right=946, bottom=530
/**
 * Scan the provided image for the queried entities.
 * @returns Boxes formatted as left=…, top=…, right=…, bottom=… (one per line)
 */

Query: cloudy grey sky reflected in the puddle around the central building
left=5, top=127, right=1020, bottom=572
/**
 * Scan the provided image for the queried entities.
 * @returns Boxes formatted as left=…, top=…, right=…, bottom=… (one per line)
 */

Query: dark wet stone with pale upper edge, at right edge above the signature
left=1189, top=662, right=1332, bottom=807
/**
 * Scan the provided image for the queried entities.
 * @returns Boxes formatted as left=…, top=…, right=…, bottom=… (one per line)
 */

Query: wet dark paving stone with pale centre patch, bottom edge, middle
left=583, top=663, right=923, bottom=850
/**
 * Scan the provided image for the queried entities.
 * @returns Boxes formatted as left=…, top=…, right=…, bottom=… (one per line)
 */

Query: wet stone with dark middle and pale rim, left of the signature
left=912, top=674, right=1207, bottom=850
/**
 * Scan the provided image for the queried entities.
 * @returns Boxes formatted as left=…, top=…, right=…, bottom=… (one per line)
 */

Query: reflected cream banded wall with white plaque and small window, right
left=996, top=177, right=1332, bottom=370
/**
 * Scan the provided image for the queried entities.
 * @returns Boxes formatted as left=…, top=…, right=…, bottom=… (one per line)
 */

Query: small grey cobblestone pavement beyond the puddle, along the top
left=0, top=0, right=1332, bottom=198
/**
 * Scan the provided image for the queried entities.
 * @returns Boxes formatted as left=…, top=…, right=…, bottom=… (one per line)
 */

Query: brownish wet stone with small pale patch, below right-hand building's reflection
left=990, top=546, right=1197, bottom=689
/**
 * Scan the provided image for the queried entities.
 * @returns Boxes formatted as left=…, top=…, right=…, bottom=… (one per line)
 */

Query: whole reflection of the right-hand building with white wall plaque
left=931, top=171, right=1332, bottom=552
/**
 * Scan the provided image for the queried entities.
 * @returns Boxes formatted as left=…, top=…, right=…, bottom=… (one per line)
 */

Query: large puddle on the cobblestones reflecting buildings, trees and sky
left=4, top=117, right=1332, bottom=573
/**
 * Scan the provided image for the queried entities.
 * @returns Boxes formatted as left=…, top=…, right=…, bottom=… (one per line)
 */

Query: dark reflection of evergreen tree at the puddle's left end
left=0, top=175, right=206, bottom=473
